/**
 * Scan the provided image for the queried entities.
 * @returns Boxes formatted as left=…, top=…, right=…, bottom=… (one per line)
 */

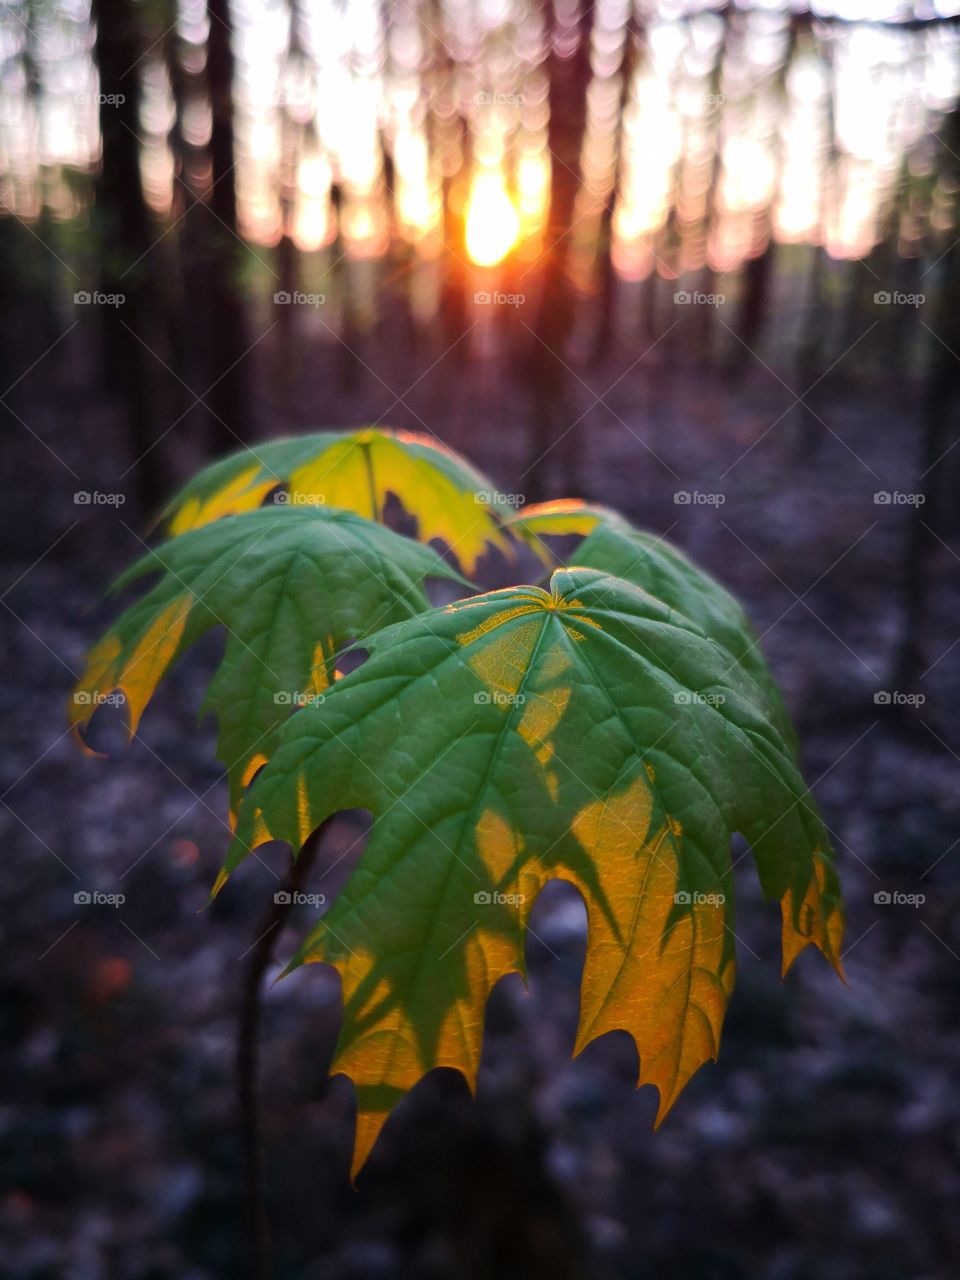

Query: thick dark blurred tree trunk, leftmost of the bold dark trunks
left=92, top=0, right=166, bottom=515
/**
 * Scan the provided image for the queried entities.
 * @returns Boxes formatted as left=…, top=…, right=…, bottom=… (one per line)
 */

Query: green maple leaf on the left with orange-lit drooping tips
left=69, top=507, right=463, bottom=810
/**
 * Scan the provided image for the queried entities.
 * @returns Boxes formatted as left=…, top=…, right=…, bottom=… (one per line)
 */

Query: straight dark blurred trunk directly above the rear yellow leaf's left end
left=204, top=0, right=252, bottom=453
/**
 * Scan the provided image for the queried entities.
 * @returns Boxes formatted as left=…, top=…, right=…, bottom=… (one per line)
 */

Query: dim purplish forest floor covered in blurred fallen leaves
left=0, top=312, right=960, bottom=1280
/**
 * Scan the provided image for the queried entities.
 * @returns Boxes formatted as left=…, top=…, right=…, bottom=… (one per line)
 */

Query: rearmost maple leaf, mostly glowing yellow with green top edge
left=164, top=428, right=512, bottom=575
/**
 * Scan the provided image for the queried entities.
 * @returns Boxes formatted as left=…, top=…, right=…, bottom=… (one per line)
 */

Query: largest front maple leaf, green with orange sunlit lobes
left=216, top=568, right=842, bottom=1171
